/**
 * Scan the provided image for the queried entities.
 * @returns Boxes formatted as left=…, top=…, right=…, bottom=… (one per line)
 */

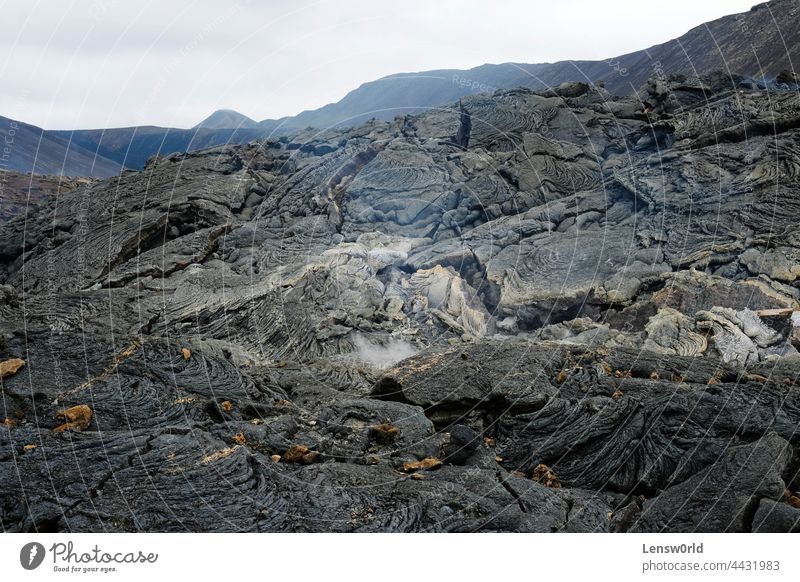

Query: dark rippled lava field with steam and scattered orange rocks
left=0, top=76, right=800, bottom=532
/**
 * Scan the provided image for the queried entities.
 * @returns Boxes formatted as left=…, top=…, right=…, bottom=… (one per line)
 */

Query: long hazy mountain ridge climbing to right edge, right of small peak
left=276, top=0, right=800, bottom=127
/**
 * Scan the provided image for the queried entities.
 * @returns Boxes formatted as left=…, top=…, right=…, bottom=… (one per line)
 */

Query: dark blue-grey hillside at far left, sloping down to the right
left=0, top=117, right=122, bottom=178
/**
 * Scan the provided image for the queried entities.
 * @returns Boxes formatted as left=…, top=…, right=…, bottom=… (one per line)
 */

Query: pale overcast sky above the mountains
left=0, top=0, right=758, bottom=129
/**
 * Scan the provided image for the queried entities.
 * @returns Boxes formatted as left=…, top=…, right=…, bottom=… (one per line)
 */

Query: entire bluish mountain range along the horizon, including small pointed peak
left=3, top=0, right=800, bottom=177
